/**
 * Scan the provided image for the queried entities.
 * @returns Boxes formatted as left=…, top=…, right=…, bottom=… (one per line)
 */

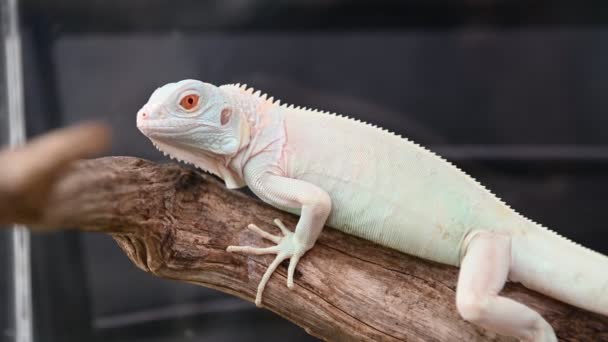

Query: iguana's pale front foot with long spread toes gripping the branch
left=226, top=219, right=307, bottom=306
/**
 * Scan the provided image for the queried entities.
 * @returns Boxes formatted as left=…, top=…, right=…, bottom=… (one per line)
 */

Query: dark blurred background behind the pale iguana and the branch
left=0, top=0, right=608, bottom=342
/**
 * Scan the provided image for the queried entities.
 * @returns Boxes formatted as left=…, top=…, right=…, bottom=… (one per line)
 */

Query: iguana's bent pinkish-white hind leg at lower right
left=456, top=231, right=557, bottom=342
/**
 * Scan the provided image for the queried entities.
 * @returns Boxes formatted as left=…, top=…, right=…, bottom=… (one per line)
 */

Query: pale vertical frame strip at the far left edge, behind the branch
left=0, top=0, right=33, bottom=342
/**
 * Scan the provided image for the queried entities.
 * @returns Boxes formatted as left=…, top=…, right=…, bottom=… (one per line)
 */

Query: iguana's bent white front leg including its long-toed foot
left=226, top=172, right=331, bottom=306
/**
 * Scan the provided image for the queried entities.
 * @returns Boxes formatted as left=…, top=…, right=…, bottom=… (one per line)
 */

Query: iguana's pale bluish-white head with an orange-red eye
left=137, top=80, right=249, bottom=188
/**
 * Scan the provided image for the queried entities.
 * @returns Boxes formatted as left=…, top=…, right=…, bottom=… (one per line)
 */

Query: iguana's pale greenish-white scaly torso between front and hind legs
left=274, top=107, right=525, bottom=265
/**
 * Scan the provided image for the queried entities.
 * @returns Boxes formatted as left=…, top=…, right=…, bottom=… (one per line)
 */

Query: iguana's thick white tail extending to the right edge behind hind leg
left=510, top=222, right=608, bottom=316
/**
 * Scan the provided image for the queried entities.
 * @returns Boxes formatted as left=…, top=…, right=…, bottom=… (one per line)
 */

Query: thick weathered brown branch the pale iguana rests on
left=8, top=157, right=608, bottom=341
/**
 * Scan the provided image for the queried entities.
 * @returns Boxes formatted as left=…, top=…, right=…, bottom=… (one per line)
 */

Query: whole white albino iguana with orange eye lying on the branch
left=137, top=80, right=608, bottom=341
